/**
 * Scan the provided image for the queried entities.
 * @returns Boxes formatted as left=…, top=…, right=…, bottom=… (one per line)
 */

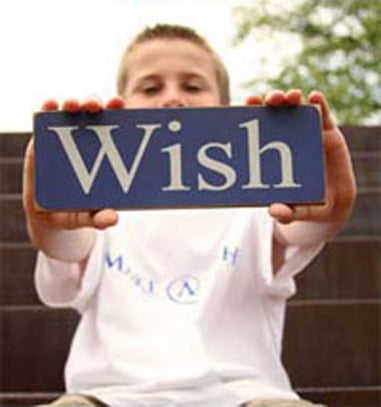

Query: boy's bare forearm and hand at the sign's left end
left=23, top=100, right=122, bottom=262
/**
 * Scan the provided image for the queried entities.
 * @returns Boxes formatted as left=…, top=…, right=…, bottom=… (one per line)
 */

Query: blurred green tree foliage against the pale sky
left=235, top=0, right=381, bottom=124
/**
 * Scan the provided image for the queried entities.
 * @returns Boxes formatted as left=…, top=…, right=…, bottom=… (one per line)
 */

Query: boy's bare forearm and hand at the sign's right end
left=249, top=90, right=356, bottom=271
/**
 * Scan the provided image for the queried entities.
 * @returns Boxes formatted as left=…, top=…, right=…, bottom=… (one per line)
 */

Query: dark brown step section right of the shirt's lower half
left=283, top=300, right=381, bottom=388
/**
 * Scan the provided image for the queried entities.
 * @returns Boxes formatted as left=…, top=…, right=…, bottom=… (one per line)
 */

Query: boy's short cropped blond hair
left=117, top=24, right=230, bottom=105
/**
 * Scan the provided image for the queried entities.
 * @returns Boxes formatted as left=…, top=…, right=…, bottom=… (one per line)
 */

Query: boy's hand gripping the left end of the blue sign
left=23, top=98, right=125, bottom=260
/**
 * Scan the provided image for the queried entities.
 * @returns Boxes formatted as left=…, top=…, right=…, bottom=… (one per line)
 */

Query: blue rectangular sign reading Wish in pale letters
left=34, top=106, right=325, bottom=210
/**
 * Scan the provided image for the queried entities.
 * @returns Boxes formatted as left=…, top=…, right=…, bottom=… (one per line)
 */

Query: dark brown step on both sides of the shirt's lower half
left=0, top=300, right=381, bottom=392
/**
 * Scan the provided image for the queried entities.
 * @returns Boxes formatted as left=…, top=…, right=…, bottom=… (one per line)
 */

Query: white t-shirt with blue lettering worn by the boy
left=36, top=208, right=321, bottom=407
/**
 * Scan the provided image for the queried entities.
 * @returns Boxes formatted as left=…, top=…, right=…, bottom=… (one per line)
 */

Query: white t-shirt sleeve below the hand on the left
left=35, top=232, right=104, bottom=312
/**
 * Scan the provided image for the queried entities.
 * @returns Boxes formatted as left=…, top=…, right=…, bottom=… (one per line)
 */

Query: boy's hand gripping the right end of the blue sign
left=247, top=90, right=356, bottom=243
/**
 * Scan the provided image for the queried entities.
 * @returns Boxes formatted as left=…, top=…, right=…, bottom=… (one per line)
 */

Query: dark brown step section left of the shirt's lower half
left=0, top=306, right=78, bottom=392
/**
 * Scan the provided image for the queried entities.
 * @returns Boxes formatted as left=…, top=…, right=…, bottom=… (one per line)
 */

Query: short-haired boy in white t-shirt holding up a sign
left=24, top=25, right=355, bottom=407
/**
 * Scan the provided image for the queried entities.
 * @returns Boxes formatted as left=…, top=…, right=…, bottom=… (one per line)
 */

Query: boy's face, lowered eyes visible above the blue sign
left=124, top=39, right=221, bottom=108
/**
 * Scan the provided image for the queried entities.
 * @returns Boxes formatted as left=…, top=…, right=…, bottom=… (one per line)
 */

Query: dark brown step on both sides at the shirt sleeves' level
left=0, top=240, right=381, bottom=305
